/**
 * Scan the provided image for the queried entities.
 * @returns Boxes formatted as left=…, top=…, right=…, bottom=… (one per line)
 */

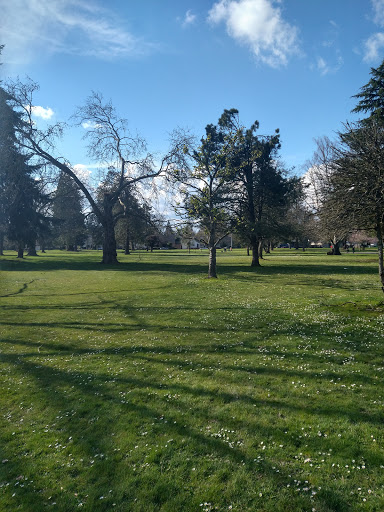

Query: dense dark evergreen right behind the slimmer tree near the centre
left=219, top=109, right=295, bottom=266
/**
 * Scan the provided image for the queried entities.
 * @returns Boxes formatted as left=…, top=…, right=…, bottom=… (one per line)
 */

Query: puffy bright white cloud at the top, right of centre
left=208, top=0, right=298, bottom=68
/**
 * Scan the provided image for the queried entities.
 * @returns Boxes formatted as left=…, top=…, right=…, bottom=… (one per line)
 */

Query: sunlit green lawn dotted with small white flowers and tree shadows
left=0, top=249, right=384, bottom=512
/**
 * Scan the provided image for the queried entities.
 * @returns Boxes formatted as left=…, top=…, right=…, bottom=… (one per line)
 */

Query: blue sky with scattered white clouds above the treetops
left=0, top=0, right=384, bottom=174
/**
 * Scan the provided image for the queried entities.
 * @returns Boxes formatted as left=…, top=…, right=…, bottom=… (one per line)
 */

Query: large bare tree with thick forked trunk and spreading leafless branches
left=7, top=81, right=183, bottom=264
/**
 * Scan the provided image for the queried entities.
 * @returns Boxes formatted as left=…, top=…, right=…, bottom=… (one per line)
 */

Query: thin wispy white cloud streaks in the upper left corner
left=0, top=0, right=155, bottom=65
